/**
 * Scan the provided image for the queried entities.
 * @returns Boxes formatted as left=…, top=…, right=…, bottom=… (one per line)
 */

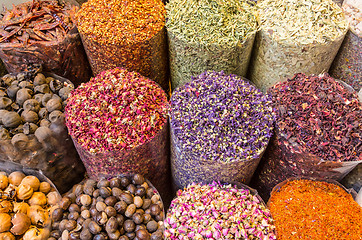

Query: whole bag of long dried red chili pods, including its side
left=0, top=0, right=91, bottom=85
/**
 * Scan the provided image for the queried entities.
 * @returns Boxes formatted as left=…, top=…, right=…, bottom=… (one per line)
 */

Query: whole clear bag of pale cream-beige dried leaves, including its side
left=249, top=0, right=348, bottom=91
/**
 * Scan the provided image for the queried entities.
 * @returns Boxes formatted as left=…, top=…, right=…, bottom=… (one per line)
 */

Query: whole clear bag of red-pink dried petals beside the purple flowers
left=65, top=68, right=170, bottom=202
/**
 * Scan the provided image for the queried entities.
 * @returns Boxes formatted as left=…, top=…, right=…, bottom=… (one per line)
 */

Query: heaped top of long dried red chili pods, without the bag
left=0, top=1, right=74, bottom=45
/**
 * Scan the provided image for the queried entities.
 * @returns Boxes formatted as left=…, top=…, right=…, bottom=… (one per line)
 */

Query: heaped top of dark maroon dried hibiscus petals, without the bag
left=269, top=73, right=362, bottom=162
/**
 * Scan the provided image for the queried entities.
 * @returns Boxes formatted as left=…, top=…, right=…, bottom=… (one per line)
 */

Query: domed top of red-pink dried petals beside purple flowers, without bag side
left=65, top=68, right=168, bottom=153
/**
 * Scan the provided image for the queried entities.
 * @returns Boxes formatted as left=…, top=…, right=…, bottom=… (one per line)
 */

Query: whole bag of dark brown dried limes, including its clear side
left=0, top=66, right=85, bottom=192
